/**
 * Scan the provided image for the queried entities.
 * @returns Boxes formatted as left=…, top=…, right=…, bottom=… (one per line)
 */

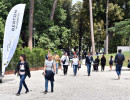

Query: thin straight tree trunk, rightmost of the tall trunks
left=105, top=0, right=109, bottom=54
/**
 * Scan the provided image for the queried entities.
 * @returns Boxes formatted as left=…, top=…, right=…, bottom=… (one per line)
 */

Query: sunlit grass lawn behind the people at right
left=94, top=51, right=130, bottom=66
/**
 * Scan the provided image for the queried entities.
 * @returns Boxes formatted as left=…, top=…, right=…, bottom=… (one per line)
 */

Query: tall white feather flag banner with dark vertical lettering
left=2, top=4, right=26, bottom=75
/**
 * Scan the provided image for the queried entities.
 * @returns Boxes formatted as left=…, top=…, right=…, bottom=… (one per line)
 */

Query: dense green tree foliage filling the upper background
left=0, top=0, right=130, bottom=52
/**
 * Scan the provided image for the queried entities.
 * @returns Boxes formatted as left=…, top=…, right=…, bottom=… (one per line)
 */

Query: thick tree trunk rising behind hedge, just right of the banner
left=28, top=0, right=34, bottom=50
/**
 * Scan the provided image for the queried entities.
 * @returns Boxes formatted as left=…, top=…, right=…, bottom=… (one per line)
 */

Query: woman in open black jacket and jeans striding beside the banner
left=14, top=54, right=31, bottom=96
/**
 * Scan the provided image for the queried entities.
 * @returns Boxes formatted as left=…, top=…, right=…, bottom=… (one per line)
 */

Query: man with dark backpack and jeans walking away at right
left=115, top=49, right=125, bottom=80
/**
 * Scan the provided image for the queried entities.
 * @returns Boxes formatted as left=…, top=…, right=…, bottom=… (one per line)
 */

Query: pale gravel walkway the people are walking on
left=0, top=66, right=130, bottom=100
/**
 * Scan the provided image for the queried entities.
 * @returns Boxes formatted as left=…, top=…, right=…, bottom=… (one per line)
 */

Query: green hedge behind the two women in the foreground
left=6, top=47, right=62, bottom=70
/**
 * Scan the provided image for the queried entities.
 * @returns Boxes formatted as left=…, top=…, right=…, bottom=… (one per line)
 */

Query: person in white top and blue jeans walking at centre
left=71, top=54, right=80, bottom=76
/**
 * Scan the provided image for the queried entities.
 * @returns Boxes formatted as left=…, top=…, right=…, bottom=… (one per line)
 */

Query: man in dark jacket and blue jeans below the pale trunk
left=86, top=53, right=93, bottom=76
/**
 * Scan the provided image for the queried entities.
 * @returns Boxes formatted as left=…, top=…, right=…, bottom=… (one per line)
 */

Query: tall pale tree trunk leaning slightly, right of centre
left=89, top=0, right=95, bottom=55
